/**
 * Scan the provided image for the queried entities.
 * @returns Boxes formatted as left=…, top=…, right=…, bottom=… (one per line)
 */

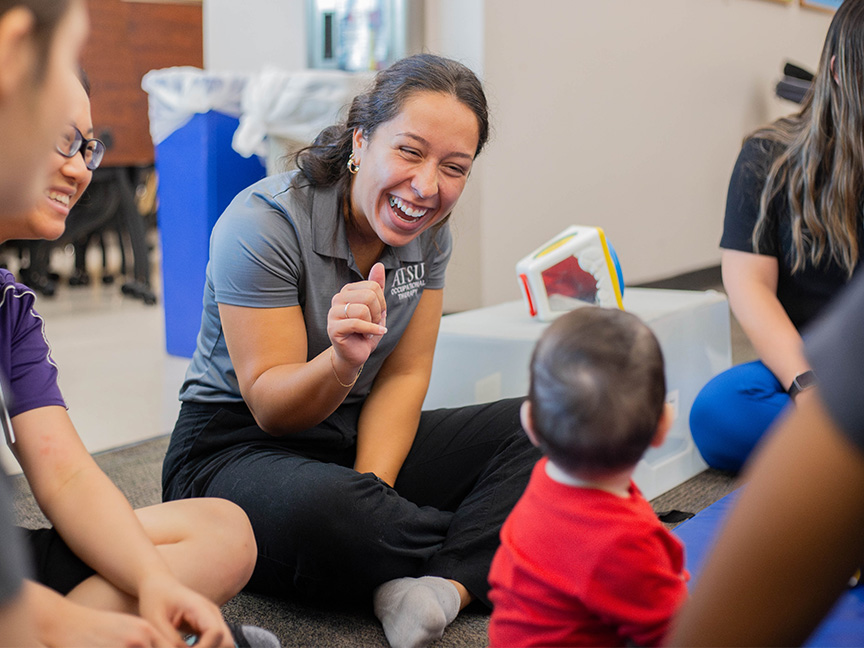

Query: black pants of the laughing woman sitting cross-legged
left=162, top=399, right=540, bottom=605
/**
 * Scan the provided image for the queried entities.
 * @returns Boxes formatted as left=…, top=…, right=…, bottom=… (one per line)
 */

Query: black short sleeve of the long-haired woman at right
left=720, top=138, right=777, bottom=256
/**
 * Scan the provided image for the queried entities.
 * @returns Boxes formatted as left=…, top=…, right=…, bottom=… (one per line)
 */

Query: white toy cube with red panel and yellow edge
left=516, top=225, right=624, bottom=322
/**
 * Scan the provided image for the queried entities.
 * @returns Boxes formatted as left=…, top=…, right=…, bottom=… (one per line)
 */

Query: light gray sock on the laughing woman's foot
left=372, top=576, right=461, bottom=648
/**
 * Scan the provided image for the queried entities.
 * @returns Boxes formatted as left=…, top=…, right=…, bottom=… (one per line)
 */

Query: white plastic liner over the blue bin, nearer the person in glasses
left=141, top=67, right=249, bottom=146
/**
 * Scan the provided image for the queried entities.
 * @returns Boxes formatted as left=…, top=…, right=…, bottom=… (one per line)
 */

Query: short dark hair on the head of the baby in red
left=528, top=306, right=666, bottom=474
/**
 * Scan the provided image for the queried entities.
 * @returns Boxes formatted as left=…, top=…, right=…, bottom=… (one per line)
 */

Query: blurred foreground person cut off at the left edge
left=0, top=0, right=88, bottom=646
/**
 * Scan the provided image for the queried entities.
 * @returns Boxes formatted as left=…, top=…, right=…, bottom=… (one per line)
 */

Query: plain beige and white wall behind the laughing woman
left=204, top=0, right=831, bottom=310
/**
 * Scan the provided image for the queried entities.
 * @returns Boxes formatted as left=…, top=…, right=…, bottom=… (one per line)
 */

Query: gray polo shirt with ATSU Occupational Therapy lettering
left=180, top=172, right=452, bottom=404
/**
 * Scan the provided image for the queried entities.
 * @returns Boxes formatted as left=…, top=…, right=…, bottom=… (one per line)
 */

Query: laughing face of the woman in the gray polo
left=351, top=91, right=479, bottom=247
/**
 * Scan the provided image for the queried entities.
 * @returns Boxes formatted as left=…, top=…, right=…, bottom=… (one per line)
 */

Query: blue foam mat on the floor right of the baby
left=673, top=489, right=864, bottom=646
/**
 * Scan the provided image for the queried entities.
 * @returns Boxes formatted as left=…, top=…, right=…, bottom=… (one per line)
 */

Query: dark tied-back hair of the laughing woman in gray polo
left=295, top=54, right=489, bottom=196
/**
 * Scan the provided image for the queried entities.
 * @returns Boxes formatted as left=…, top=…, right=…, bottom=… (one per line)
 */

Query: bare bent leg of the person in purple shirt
left=68, top=498, right=257, bottom=614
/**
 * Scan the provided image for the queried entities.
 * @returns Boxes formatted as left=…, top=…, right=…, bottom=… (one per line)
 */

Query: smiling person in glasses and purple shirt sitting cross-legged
left=0, top=72, right=279, bottom=647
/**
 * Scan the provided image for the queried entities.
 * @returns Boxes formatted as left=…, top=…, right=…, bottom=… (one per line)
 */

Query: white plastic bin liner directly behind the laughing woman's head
left=232, top=68, right=373, bottom=157
